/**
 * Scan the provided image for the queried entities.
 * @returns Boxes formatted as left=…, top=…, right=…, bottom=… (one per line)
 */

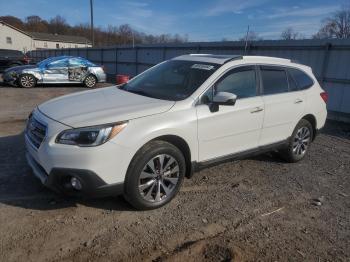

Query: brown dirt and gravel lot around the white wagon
left=0, top=87, right=350, bottom=261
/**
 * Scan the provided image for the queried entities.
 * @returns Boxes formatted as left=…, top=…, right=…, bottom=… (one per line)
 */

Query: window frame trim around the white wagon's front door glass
left=195, top=63, right=262, bottom=105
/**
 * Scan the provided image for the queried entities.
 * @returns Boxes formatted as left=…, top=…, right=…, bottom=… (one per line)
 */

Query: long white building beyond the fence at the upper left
left=0, top=21, right=92, bottom=52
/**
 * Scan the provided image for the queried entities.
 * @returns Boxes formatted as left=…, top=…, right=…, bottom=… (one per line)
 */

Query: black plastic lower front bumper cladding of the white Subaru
left=26, top=152, right=124, bottom=197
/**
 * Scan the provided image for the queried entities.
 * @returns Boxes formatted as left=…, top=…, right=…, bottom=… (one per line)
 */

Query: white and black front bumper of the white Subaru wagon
left=25, top=109, right=132, bottom=196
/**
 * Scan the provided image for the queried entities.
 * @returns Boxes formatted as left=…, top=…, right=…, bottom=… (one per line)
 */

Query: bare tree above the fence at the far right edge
left=313, top=6, right=350, bottom=39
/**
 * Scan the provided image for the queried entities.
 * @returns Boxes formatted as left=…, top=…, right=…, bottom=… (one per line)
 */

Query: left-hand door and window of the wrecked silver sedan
left=43, top=58, right=69, bottom=83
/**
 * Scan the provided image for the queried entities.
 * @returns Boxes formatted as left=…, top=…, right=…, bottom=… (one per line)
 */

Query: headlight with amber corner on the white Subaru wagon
left=56, top=122, right=127, bottom=146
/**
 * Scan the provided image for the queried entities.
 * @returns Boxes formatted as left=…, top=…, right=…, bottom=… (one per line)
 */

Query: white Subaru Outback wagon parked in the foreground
left=25, top=54, right=327, bottom=209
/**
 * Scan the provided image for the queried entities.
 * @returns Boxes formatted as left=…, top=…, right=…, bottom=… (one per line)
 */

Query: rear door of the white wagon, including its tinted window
left=259, top=66, right=305, bottom=146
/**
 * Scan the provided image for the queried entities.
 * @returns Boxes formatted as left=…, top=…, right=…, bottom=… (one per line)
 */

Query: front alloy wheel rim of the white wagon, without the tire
left=138, top=154, right=180, bottom=202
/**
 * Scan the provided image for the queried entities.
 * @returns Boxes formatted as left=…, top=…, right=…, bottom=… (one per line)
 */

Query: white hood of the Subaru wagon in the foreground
left=38, top=86, right=175, bottom=128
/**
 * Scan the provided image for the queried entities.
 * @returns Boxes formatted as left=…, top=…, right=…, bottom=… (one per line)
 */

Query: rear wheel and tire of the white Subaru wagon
left=280, top=119, right=314, bottom=163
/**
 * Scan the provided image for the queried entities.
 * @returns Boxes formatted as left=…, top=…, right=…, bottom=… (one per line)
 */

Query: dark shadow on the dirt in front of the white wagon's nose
left=0, top=133, right=134, bottom=211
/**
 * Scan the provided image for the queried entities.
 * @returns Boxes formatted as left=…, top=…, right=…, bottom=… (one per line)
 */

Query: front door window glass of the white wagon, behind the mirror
left=215, top=66, right=256, bottom=99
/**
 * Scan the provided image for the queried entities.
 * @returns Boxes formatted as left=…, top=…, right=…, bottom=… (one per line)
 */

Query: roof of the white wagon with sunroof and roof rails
left=173, top=54, right=292, bottom=65
